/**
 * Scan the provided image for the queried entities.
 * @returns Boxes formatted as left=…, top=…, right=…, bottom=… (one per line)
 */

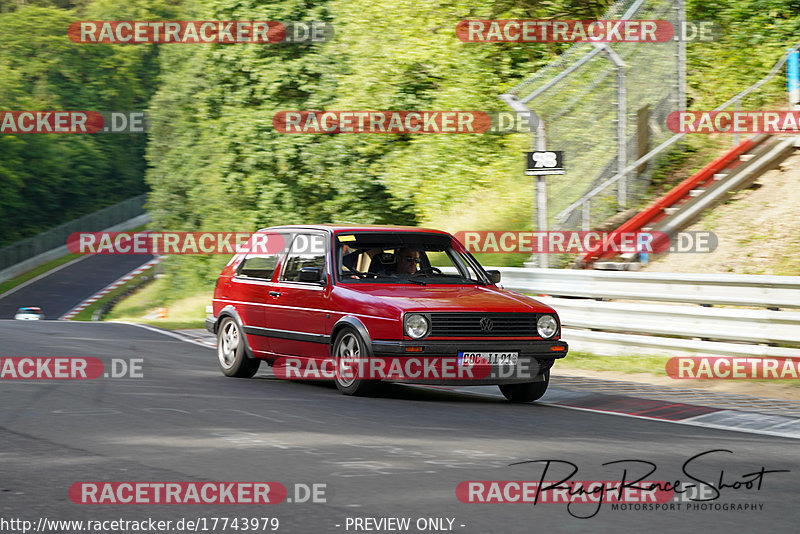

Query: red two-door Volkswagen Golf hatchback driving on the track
left=206, top=226, right=567, bottom=402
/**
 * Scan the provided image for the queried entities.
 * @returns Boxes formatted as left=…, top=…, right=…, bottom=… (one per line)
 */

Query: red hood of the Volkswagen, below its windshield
left=349, top=285, right=554, bottom=313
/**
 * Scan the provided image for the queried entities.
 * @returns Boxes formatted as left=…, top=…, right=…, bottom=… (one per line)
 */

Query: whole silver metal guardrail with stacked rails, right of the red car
left=499, top=267, right=800, bottom=358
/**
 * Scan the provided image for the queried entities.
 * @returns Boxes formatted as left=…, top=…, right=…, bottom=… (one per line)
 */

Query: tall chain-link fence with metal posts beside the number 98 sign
left=508, top=0, right=685, bottom=239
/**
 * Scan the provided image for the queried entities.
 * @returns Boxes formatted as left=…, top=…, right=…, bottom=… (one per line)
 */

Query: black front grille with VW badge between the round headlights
left=429, top=312, right=540, bottom=337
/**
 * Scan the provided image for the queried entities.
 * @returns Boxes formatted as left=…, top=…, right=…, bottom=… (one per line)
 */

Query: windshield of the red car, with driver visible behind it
left=336, top=232, right=489, bottom=285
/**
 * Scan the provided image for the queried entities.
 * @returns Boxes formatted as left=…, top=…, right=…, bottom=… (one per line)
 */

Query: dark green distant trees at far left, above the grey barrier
left=0, top=1, right=171, bottom=246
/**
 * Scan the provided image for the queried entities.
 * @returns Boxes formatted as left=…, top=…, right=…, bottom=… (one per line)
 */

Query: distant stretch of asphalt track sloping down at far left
left=0, top=254, right=153, bottom=319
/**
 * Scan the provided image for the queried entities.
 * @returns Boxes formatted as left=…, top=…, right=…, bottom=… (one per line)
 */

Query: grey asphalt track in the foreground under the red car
left=0, top=321, right=800, bottom=533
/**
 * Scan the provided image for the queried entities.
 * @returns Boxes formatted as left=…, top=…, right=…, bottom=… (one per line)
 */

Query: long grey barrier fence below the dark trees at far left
left=0, top=194, right=147, bottom=270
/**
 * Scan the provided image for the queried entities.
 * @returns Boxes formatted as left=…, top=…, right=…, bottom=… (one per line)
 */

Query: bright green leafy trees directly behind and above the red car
left=147, top=0, right=607, bottom=291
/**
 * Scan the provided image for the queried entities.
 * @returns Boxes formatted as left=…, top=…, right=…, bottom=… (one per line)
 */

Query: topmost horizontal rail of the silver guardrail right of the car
left=499, top=267, right=800, bottom=310
